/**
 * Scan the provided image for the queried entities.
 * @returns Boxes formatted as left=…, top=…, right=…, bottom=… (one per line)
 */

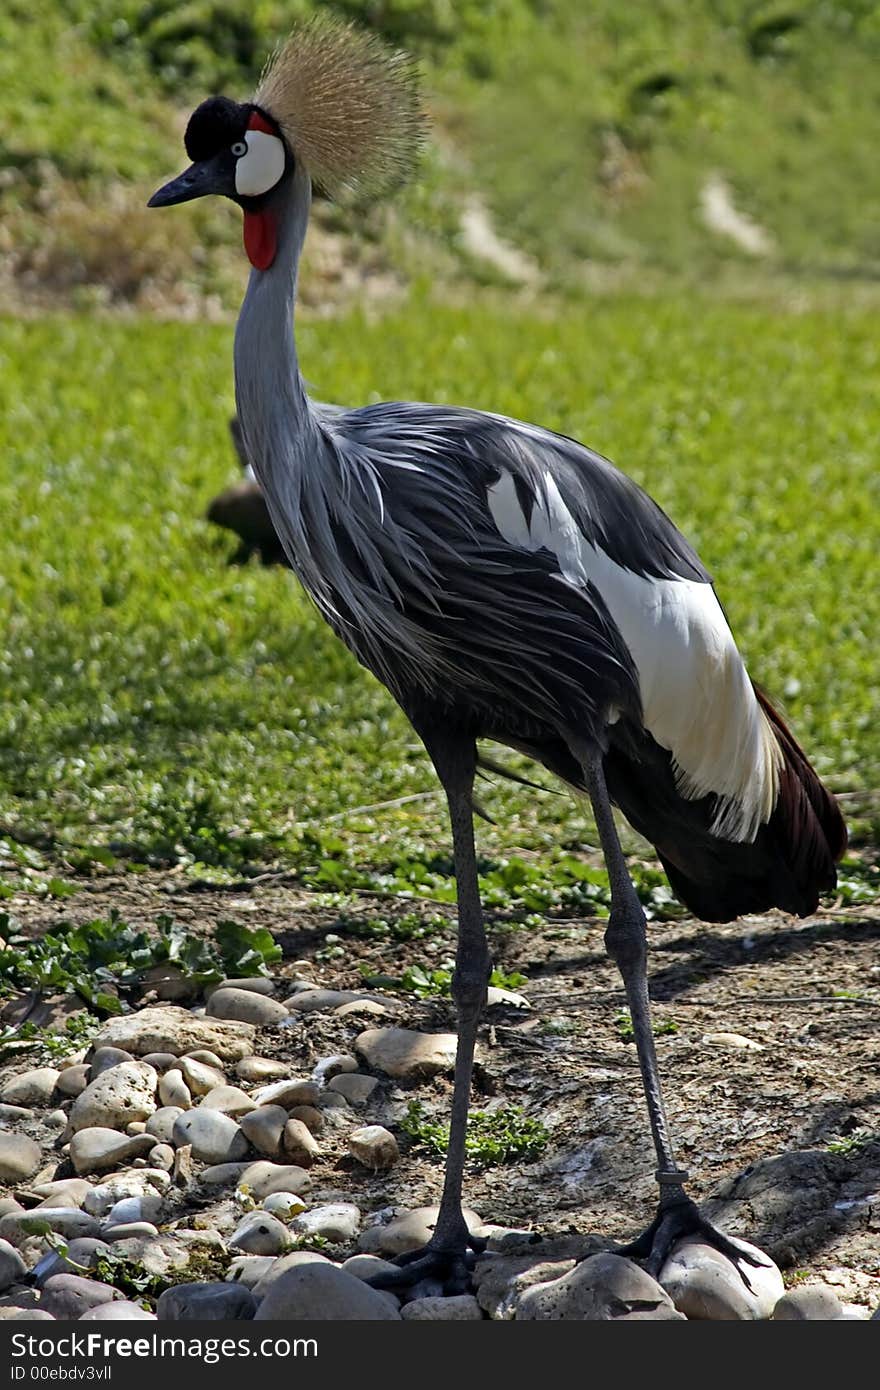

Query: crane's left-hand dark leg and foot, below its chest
left=370, top=734, right=491, bottom=1294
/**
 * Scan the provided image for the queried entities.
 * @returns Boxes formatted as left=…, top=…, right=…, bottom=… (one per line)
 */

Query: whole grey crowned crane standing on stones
left=150, top=22, right=845, bottom=1291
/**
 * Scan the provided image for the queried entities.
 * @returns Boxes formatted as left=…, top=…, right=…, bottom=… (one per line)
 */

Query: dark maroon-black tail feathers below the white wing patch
left=514, top=689, right=847, bottom=922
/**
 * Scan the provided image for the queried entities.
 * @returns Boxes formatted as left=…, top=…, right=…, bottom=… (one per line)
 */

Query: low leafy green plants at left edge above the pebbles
left=0, top=910, right=281, bottom=1017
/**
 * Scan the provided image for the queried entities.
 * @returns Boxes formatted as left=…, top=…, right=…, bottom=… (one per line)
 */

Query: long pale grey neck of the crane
left=235, top=170, right=327, bottom=543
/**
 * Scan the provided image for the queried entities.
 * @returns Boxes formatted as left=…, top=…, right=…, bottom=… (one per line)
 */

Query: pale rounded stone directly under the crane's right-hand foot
left=659, top=1236, right=785, bottom=1322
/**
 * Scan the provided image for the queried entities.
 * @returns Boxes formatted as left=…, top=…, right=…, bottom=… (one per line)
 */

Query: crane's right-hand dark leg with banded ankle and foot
left=570, top=739, right=760, bottom=1287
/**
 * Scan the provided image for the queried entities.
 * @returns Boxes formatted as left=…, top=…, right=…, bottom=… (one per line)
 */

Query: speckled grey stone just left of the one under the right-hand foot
left=516, top=1251, right=684, bottom=1322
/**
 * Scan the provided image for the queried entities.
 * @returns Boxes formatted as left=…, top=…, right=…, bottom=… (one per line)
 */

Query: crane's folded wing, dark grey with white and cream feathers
left=323, top=404, right=779, bottom=840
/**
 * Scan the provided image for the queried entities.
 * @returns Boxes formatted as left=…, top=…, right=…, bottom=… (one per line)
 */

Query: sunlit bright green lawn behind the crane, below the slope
left=0, top=296, right=880, bottom=915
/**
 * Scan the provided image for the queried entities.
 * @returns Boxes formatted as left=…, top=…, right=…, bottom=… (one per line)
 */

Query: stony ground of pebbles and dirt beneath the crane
left=0, top=873, right=880, bottom=1319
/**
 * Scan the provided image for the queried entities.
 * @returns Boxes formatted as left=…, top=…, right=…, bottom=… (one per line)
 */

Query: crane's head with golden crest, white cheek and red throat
left=149, top=17, right=424, bottom=270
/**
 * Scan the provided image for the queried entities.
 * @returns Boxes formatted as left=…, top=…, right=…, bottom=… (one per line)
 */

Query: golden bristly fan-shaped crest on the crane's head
left=254, top=15, right=425, bottom=197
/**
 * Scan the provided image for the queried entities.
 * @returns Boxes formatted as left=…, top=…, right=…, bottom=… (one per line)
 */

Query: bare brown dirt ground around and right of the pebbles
left=1, top=873, right=880, bottom=1308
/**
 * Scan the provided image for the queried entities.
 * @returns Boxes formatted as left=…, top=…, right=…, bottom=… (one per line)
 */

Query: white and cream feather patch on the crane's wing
left=488, top=473, right=781, bottom=842
